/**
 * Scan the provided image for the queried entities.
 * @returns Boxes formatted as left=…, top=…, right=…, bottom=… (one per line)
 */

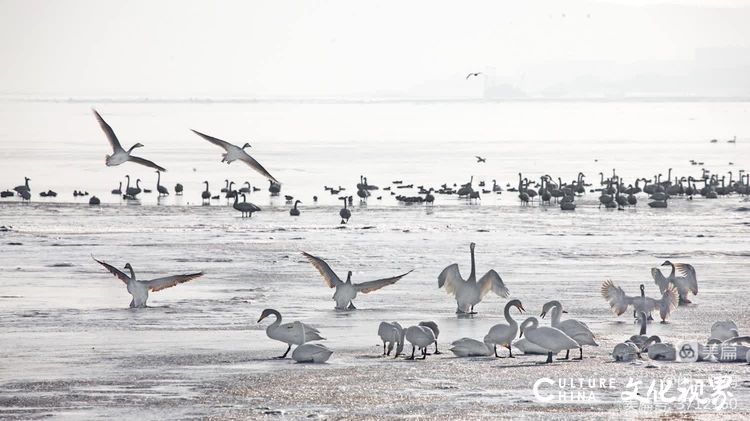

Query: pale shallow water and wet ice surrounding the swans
left=0, top=103, right=750, bottom=419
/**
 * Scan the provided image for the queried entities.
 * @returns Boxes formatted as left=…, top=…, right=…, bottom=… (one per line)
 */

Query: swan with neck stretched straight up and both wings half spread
left=438, top=243, right=510, bottom=314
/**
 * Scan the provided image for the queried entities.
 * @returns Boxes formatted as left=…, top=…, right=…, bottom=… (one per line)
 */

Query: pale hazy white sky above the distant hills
left=0, top=0, right=750, bottom=97
